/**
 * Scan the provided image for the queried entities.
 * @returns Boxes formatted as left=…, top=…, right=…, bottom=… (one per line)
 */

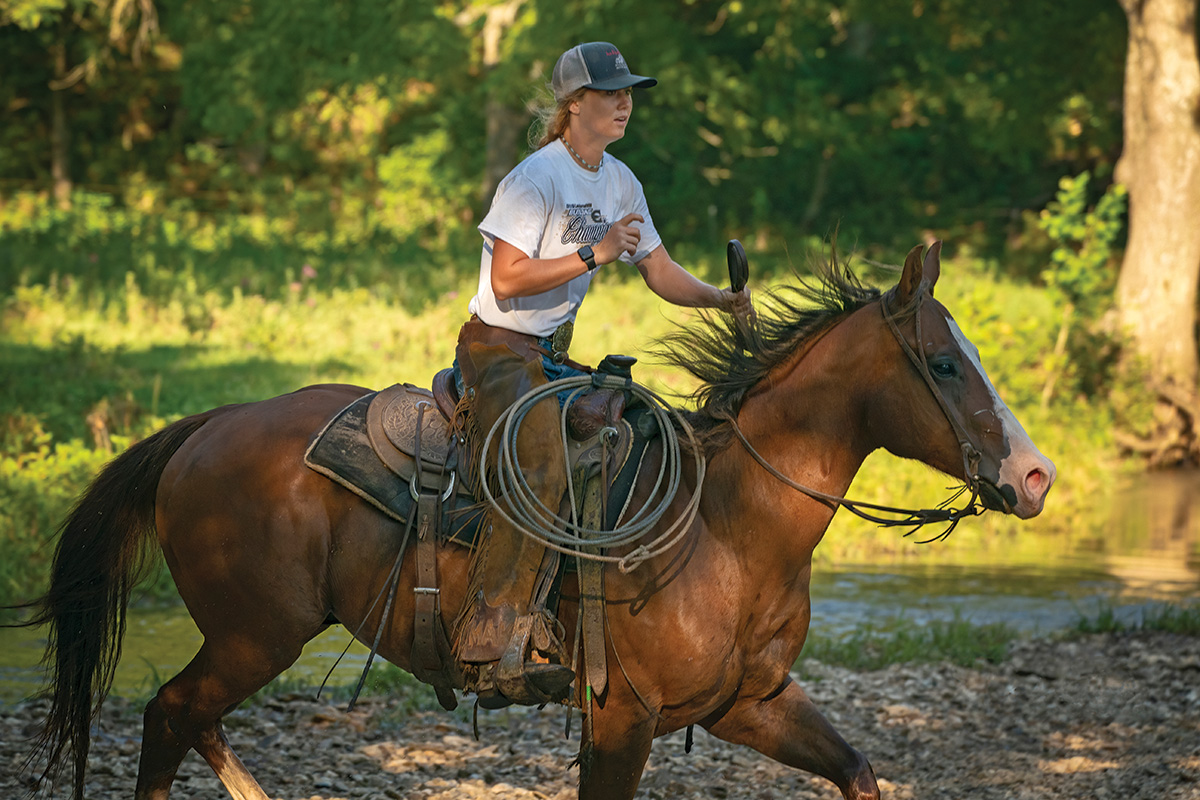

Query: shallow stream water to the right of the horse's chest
left=812, top=471, right=1200, bottom=636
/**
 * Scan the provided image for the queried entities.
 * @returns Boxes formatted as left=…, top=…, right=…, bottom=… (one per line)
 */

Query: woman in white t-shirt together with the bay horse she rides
left=9, top=38, right=1056, bottom=800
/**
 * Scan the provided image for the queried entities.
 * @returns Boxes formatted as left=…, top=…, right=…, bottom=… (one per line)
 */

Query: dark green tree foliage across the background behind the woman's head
left=0, top=0, right=1123, bottom=250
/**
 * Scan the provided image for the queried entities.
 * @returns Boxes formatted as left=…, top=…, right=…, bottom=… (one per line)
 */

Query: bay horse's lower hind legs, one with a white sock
left=134, top=642, right=299, bottom=800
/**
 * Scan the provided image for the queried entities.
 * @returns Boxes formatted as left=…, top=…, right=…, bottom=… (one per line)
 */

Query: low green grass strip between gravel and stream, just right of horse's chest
left=799, top=615, right=1018, bottom=672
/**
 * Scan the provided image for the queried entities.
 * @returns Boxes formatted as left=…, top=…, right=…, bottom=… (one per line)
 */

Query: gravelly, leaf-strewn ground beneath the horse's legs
left=0, top=633, right=1200, bottom=800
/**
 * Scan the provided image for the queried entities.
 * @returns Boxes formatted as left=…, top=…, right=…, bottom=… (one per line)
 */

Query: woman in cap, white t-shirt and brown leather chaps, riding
left=455, top=42, right=752, bottom=704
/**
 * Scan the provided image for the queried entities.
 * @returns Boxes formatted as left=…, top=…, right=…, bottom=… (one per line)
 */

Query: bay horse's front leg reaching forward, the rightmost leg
left=704, top=678, right=880, bottom=800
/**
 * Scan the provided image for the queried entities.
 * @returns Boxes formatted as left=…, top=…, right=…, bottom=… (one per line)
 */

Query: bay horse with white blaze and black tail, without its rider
left=14, top=243, right=1055, bottom=800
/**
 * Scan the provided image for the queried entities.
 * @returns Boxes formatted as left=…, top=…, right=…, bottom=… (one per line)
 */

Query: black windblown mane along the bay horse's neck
left=654, top=247, right=910, bottom=452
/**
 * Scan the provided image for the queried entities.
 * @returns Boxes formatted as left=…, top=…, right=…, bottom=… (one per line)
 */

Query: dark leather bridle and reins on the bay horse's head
left=725, top=288, right=984, bottom=545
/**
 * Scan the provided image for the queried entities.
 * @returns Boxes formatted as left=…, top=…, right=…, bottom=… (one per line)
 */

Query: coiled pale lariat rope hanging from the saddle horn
left=479, top=373, right=706, bottom=572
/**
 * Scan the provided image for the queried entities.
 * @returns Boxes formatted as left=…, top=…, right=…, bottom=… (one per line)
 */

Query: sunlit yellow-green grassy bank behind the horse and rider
left=0, top=231, right=1118, bottom=603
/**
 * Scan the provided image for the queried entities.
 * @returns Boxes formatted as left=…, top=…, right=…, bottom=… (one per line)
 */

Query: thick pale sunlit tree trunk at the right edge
left=1116, top=0, right=1200, bottom=465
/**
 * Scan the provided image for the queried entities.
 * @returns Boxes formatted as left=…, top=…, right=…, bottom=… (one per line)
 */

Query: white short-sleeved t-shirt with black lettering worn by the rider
left=469, top=139, right=662, bottom=337
